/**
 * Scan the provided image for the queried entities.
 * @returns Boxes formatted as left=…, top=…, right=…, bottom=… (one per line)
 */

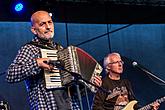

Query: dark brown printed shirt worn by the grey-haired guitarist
left=93, top=76, right=135, bottom=110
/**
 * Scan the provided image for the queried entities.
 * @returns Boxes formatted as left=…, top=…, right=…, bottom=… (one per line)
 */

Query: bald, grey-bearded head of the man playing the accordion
left=31, top=11, right=54, bottom=40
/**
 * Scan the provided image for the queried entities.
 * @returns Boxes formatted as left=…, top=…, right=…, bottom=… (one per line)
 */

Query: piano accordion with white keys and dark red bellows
left=41, top=46, right=102, bottom=89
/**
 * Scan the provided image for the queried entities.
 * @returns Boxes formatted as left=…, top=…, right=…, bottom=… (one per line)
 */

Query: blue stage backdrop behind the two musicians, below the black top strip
left=0, top=22, right=165, bottom=110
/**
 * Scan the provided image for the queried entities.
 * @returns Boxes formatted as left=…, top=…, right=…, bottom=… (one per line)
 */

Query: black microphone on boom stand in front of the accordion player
left=55, top=64, right=111, bottom=110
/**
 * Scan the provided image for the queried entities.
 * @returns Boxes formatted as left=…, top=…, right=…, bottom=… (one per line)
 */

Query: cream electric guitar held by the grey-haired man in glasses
left=122, top=96, right=165, bottom=110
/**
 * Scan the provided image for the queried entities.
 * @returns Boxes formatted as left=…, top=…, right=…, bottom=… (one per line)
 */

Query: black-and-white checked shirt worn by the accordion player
left=6, top=38, right=79, bottom=110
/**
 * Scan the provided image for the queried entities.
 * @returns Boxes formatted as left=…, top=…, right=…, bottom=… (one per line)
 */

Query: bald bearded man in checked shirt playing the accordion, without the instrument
left=7, top=11, right=79, bottom=110
